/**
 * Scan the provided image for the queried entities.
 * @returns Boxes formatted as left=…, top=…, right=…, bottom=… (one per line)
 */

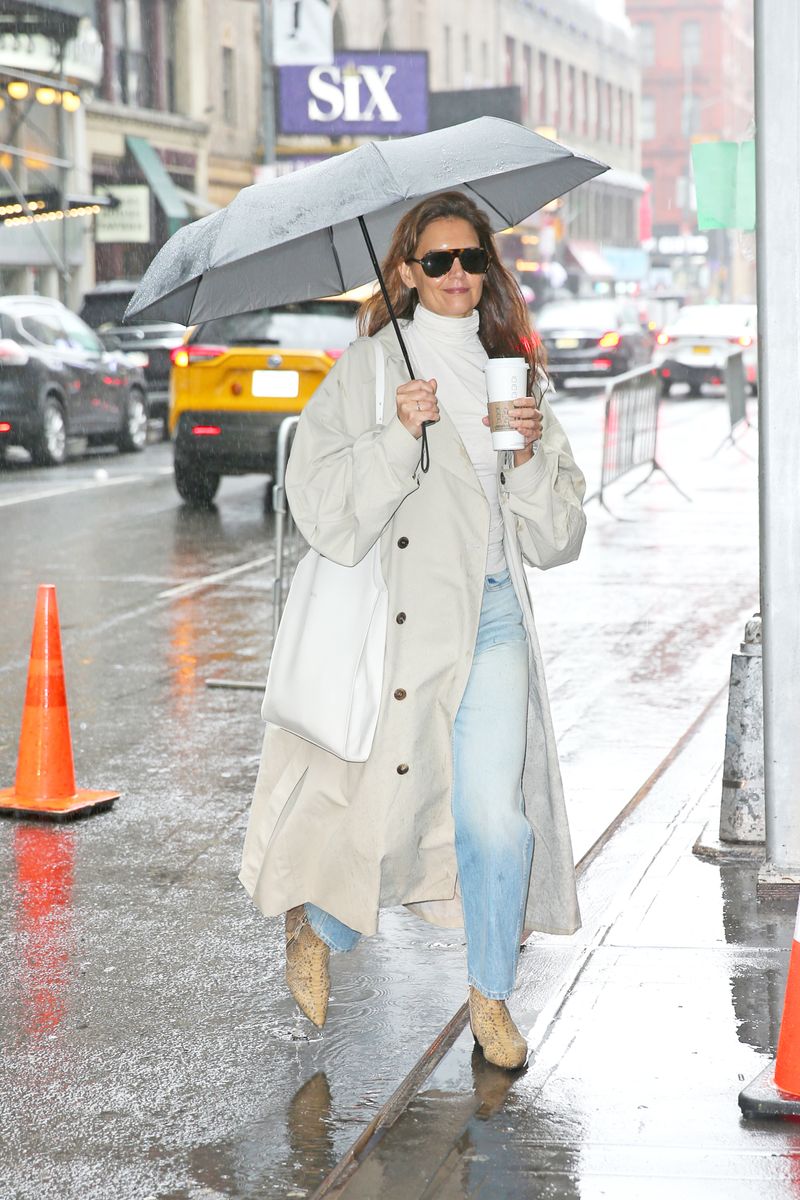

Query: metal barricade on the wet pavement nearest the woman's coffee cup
left=587, top=364, right=688, bottom=516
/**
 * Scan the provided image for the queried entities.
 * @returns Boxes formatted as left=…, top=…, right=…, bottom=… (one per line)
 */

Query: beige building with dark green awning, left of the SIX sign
left=88, top=0, right=260, bottom=288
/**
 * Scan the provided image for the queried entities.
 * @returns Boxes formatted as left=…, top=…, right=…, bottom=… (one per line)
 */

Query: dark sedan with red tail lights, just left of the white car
left=534, top=298, right=652, bottom=386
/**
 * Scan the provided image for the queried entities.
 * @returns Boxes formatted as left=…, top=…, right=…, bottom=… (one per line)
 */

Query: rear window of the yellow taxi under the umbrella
left=190, top=300, right=359, bottom=350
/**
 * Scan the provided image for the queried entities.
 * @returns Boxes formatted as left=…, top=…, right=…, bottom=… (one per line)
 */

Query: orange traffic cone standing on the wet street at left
left=0, top=583, right=120, bottom=821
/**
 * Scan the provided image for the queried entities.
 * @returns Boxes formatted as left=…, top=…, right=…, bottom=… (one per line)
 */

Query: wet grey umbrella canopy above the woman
left=126, top=116, right=608, bottom=325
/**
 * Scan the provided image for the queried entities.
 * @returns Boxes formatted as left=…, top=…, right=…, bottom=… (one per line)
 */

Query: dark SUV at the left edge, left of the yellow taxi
left=0, top=296, right=148, bottom=466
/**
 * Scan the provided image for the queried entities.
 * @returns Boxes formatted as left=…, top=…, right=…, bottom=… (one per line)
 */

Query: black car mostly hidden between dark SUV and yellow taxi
left=80, top=280, right=186, bottom=437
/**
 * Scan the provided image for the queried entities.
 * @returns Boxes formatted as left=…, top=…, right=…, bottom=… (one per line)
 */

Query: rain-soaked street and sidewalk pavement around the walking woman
left=0, top=396, right=800, bottom=1200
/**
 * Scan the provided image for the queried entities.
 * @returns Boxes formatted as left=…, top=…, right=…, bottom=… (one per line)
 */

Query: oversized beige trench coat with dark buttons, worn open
left=240, top=326, right=585, bottom=934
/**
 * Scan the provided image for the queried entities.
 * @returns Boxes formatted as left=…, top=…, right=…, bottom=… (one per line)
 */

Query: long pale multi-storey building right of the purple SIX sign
left=314, top=0, right=646, bottom=300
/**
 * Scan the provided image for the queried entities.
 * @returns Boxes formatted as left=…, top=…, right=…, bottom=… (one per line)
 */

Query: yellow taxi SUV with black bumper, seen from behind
left=169, top=289, right=372, bottom=505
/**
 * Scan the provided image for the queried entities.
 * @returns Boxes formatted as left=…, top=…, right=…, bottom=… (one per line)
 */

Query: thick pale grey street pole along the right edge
left=754, top=0, right=800, bottom=894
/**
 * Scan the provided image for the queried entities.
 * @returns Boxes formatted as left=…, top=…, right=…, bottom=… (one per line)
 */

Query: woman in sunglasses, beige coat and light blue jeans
left=241, top=192, right=585, bottom=1068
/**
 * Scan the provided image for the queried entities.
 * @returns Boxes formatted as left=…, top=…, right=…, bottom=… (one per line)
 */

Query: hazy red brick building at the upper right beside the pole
left=627, top=0, right=754, bottom=299
